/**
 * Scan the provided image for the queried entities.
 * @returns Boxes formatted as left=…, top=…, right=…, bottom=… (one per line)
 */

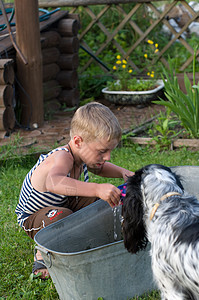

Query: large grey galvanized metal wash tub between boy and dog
left=35, top=166, right=199, bottom=300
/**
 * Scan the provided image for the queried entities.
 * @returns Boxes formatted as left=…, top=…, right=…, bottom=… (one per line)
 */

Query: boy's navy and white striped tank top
left=15, top=148, right=89, bottom=227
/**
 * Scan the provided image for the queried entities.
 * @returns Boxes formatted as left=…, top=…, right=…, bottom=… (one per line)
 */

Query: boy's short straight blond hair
left=70, top=102, right=122, bottom=142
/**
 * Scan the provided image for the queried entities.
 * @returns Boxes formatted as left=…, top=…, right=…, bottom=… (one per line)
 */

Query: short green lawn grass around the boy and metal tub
left=0, top=145, right=199, bottom=300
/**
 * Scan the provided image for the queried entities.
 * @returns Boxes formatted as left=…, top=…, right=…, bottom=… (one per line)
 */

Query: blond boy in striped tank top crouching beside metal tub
left=16, top=102, right=134, bottom=279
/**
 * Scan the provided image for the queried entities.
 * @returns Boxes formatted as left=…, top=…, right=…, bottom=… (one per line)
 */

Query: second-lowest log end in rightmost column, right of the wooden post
left=57, top=70, right=78, bottom=89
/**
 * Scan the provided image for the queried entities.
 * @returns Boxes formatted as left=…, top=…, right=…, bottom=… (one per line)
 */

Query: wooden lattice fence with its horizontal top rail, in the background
left=39, top=0, right=199, bottom=72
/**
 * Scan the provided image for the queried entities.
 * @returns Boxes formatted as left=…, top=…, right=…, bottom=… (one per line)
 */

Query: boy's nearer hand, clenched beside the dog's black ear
left=97, top=183, right=121, bottom=208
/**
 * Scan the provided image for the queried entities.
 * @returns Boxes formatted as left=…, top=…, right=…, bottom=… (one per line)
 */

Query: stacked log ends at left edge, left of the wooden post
left=0, top=59, right=15, bottom=138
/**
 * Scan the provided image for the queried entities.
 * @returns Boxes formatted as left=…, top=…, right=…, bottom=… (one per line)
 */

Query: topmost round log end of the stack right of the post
left=58, top=19, right=79, bottom=37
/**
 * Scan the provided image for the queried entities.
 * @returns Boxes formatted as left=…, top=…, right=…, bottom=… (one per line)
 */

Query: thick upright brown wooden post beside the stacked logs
left=15, top=0, right=44, bottom=128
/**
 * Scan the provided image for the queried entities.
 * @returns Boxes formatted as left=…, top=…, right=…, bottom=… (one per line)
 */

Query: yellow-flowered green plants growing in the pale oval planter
left=107, top=40, right=159, bottom=91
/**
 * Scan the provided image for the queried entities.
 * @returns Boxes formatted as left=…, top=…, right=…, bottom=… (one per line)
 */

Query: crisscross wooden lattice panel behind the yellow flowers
left=40, top=0, right=199, bottom=72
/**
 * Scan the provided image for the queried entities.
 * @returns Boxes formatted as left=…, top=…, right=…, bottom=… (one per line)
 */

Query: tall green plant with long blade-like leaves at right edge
left=153, top=50, right=199, bottom=138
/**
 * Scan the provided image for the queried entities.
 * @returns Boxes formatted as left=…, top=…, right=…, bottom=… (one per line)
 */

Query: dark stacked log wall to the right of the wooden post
left=41, top=14, right=80, bottom=113
